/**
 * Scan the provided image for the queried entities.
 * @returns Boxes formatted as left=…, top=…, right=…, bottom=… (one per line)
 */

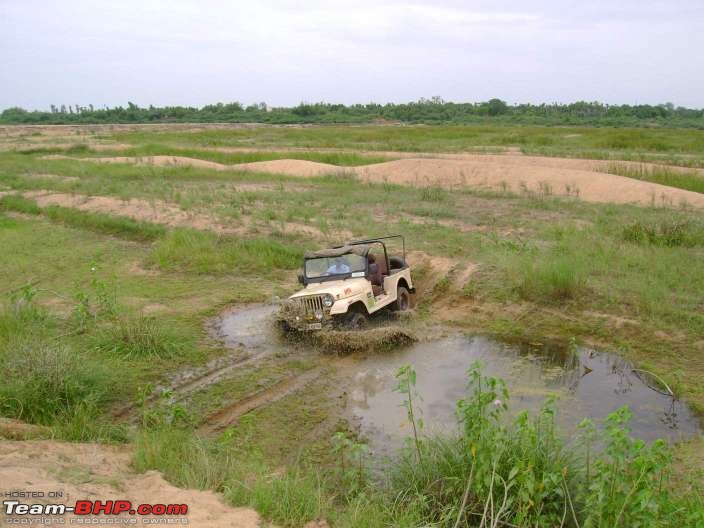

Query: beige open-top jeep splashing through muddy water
left=279, top=235, right=415, bottom=332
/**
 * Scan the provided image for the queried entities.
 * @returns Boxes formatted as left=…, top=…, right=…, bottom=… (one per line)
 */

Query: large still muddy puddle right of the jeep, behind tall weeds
left=349, top=336, right=699, bottom=456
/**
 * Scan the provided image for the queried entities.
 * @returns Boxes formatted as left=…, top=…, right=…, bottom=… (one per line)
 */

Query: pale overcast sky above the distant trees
left=0, top=0, right=704, bottom=108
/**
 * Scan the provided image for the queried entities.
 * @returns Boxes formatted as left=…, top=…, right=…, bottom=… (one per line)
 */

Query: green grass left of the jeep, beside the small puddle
left=0, top=211, right=298, bottom=440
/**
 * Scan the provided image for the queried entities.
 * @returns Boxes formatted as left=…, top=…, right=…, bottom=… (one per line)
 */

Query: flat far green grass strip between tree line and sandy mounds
left=111, top=125, right=704, bottom=166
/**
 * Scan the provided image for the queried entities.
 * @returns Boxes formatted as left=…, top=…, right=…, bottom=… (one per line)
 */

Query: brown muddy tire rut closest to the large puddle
left=199, top=367, right=323, bottom=435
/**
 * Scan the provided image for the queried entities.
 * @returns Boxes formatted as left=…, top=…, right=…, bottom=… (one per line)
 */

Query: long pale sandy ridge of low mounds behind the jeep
left=42, top=154, right=704, bottom=207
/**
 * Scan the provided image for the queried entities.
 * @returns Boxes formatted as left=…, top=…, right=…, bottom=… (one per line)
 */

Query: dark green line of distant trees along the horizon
left=0, top=97, right=704, bottom=128
